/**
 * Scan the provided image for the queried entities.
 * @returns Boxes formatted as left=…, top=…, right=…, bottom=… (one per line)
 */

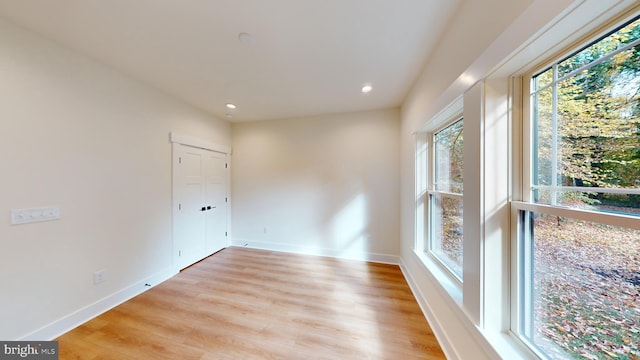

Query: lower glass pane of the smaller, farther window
left=430, top=195, right=462, bottom=279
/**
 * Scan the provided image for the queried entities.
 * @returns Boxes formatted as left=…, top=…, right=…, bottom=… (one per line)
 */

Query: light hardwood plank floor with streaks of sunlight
left=56, top=247, right=445, bottom=360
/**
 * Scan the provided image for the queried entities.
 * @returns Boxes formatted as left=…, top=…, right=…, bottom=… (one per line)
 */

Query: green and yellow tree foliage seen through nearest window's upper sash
left=533, top=20, right=640, bottom=198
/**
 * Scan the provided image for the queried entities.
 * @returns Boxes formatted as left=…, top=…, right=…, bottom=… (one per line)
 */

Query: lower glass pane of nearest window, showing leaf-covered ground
left=520, top=213, right=640, bottom=359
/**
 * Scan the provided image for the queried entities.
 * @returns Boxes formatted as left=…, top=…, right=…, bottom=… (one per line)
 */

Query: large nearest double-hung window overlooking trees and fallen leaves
left=512, top=14, right=640, bottom=359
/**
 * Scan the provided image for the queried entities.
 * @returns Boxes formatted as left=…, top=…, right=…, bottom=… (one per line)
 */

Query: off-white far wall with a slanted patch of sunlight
left=231, top=110, right=400, bottom=261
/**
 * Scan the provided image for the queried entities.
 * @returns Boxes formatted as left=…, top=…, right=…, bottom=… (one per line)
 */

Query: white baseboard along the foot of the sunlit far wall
left=231, top=239, right=400, bottom=265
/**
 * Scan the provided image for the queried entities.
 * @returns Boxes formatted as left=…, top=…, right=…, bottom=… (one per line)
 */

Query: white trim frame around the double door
left=169, top=132, right=231, bottom=272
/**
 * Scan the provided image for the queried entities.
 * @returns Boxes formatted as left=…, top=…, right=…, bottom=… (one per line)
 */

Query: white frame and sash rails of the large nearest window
left=510, top=8, right=640, bottom=358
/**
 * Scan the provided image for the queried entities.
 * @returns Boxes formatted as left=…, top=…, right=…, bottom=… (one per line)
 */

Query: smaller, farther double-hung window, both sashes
left=427, top=119, right=464, bottom=280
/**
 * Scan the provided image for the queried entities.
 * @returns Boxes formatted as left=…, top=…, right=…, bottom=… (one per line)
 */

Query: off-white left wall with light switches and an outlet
left=0, top=20, right=230, bottom=340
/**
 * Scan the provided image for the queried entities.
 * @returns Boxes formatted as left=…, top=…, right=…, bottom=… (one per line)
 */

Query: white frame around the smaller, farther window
left=414, top=86, right=488, bottom=327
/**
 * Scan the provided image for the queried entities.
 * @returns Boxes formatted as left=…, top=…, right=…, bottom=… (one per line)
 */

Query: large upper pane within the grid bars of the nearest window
left=558, top=48, right=640, bottom=193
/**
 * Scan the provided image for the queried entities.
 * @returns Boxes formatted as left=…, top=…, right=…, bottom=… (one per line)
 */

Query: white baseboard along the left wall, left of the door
left=19, top=269, right=177, bottom=341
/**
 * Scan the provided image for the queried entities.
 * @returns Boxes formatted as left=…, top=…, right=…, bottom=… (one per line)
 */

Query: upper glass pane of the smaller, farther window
left=434, top=120, right=464, bottom=194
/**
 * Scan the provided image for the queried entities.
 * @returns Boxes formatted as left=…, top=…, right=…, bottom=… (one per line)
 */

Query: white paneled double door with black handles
left=173, top=144, right=227, bottom=269
